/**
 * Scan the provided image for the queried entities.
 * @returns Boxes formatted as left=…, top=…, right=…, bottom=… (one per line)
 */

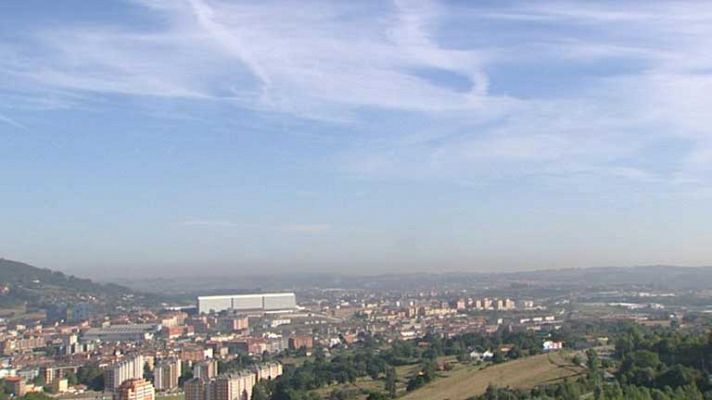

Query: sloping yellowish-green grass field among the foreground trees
left=401, top=352, right=583, bottom=400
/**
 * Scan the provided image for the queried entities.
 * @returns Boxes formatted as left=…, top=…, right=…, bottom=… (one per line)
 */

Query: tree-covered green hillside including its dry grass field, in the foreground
left=253, top=323, right=712, bottom=400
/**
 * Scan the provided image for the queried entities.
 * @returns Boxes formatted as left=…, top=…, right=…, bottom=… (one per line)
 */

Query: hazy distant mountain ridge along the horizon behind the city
left=111, top=265, right=712, bottom=294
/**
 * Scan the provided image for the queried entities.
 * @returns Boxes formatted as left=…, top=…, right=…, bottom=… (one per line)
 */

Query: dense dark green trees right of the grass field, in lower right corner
left=473, top=326, right=712, bottom=400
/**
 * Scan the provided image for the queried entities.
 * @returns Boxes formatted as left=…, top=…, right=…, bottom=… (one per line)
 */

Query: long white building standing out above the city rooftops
left=198, top=293, right=297, bottom=314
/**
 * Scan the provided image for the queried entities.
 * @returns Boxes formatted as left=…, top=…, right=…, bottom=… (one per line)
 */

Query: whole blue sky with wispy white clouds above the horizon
left=0, top=0, right=712, bottom=277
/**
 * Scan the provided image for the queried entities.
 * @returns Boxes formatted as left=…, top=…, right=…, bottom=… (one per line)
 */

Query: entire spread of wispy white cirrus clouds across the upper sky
left=0, top=0, right=712, bottom=191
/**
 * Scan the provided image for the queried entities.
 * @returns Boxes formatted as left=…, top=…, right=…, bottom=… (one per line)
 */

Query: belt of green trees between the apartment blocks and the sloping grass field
left=253, top=329, right=560, bottom=400
